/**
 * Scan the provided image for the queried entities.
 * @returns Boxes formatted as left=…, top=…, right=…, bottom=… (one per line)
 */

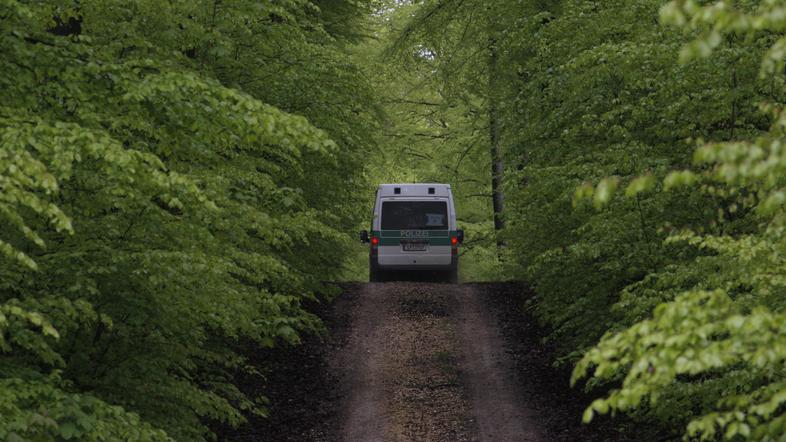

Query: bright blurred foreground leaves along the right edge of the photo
left=556, top=1, right=786, bottom=440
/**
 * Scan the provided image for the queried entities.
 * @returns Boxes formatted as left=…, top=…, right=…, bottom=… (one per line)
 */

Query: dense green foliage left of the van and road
left=0, top=0, right=375, bottom=440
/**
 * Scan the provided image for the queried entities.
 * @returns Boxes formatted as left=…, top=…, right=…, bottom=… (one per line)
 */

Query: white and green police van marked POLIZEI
left=360, top=184, right=464, bottom=283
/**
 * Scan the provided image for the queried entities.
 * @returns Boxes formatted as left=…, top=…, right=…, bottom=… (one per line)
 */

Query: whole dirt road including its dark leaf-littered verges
left=216, top=282, right=622, bottom=442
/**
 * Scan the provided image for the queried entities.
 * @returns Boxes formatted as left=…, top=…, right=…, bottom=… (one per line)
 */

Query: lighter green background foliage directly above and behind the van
left=365, top=0, right=507, bottom=281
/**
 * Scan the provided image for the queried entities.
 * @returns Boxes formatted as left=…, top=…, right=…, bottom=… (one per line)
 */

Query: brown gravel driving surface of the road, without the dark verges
left=331, top=283, right=544, bottom=441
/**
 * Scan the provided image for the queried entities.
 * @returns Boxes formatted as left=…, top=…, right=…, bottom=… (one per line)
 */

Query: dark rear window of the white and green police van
left=382, top=201, right=448, bottom=230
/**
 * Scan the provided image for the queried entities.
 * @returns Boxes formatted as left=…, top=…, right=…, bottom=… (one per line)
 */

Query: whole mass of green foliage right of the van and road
left=390, top=0, right=786, bottom=440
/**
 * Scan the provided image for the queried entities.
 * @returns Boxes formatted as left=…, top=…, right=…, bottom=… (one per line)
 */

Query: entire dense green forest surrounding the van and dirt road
left=0, top=0, right=786, bottom=441
